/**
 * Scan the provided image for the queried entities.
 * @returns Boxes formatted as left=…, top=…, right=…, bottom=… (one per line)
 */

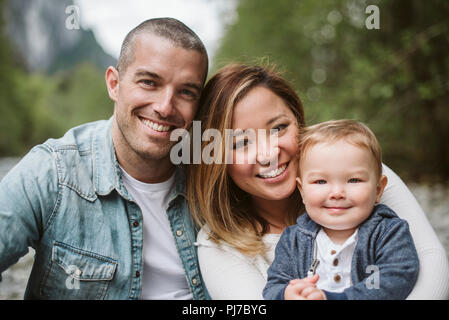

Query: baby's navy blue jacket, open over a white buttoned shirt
left=263, top=204, right=419, bottom=300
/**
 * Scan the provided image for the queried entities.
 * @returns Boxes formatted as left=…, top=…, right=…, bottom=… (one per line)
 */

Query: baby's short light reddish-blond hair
left=298, top=119, right=382, bottom=178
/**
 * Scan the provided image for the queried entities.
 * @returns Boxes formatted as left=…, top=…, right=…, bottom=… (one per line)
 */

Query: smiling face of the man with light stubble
left=110, top=34, right=206, bottom=160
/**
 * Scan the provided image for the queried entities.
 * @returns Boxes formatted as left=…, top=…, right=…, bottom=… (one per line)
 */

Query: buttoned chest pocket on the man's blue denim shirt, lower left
left=41, top=241, right=117, bottom=299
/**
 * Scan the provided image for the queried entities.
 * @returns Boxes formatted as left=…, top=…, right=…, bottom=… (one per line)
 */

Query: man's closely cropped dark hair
left=117, top=18, right=208, bottom=80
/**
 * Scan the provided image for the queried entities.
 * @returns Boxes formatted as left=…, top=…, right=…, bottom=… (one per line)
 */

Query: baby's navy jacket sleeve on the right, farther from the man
left=338, top=219, right=419, bottom=300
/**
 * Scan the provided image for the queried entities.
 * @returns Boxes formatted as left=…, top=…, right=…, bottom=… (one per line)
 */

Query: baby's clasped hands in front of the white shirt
left=284, top=274, right=326, bottom=300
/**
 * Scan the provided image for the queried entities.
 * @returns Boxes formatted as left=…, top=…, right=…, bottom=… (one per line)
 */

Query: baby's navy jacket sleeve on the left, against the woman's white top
left=263, top=228, right=299, bottom=300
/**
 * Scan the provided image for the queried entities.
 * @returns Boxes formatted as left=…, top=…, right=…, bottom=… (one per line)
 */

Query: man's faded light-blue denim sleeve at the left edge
left=0, top=145, right=58, bottom=274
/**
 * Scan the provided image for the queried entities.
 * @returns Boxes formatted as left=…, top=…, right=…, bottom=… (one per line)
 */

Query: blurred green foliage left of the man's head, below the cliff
left=0, top=0, right=113, bottom=156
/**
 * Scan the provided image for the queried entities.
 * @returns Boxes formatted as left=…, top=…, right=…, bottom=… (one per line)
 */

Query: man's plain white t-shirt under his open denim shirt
left=121, top=168, right=193, bottom=300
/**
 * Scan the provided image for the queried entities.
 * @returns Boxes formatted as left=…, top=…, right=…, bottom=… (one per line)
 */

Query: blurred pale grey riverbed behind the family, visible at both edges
left=0, top=158, right=449, bottom=300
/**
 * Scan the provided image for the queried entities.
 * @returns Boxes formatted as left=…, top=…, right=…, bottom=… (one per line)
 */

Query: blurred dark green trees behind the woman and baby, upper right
left=214, top=0, right=449, bottom=181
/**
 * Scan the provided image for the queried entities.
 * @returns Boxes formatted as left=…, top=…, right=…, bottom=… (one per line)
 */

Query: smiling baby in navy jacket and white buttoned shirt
left=263, top=120, right=419, bottom=300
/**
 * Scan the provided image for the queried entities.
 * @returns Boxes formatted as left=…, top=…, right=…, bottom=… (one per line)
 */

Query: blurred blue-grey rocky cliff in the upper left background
left=4, top=0, right=116, bottom=73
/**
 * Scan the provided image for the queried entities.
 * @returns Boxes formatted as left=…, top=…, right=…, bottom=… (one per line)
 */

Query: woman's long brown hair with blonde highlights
left=187, top=64, right=305, bottom=255
